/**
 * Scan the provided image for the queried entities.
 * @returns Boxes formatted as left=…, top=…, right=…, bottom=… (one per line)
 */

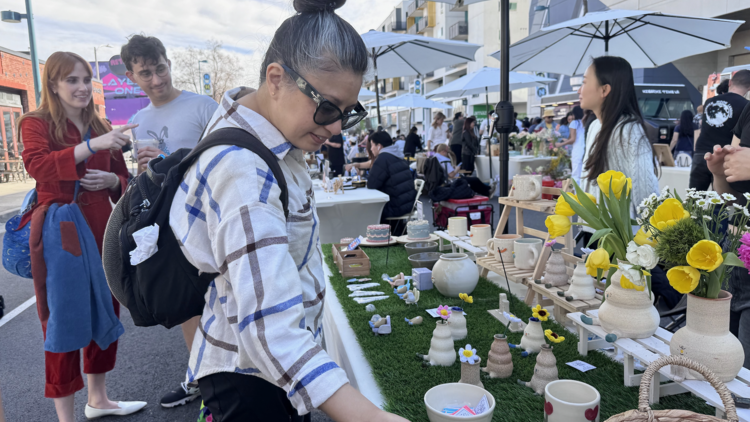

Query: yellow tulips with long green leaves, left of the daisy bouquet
left=545, top=170, right=658, bottom=294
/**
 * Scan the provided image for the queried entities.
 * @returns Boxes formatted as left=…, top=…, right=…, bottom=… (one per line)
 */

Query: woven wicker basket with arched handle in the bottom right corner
left=606, top=356, right=739, bottom=422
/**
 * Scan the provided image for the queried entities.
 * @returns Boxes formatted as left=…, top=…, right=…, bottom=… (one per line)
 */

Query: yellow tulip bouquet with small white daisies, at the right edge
left=635, top=188, right=750, bottom=299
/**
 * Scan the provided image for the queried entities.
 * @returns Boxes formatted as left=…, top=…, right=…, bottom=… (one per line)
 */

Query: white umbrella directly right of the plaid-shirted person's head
left=362, top=30, right=481, bottom=122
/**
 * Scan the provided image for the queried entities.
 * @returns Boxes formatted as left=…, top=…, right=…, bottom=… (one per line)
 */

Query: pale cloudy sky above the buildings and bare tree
left=0, top=0, right=400, bottom=83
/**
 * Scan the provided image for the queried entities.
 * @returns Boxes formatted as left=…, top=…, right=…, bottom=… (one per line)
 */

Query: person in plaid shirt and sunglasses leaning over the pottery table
left=170, top=0, right=404, bottom=422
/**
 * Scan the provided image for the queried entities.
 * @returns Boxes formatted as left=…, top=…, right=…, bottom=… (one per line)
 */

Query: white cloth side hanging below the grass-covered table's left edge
left=323, top=263, right=383, bottom=408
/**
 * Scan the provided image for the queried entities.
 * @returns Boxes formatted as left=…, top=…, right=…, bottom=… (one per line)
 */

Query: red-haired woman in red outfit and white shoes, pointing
left=19, top=52, right=146, bottom=422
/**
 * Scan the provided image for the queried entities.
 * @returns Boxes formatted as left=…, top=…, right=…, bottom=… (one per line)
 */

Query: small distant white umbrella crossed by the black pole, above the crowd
left=427, top=67, right=555, bottom=98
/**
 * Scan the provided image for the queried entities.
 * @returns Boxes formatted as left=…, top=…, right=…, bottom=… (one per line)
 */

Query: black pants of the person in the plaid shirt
left=198, top=372, right=311, bottom=422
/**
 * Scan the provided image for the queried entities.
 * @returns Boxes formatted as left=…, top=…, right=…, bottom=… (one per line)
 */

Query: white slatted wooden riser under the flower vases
left=568, top=310, right=750, bottom=421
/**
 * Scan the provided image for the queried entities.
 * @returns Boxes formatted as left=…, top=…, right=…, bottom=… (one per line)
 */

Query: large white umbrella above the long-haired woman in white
left=490, top=10, right=744, bottom=75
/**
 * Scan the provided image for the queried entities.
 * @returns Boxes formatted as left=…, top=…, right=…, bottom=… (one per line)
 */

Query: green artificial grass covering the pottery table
left=323, top=244, right=715, bottom=422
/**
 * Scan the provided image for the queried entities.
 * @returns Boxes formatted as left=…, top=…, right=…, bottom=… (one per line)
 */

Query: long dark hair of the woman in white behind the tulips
left=585, top=56, right=656, bottom=182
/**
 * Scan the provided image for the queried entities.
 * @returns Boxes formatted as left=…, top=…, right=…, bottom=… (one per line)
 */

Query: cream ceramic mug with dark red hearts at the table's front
left=544, top=380, right=601, bottom=422
